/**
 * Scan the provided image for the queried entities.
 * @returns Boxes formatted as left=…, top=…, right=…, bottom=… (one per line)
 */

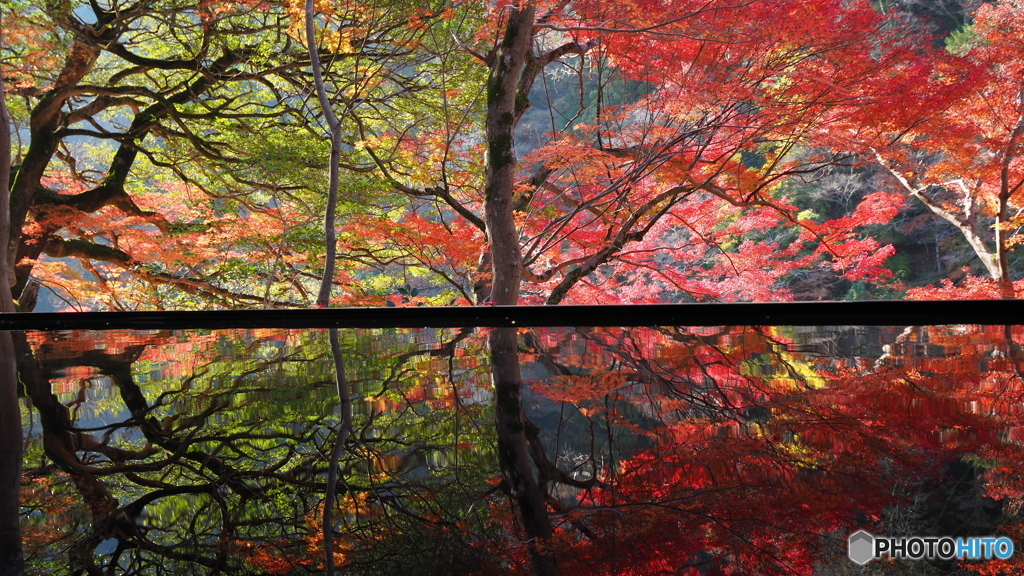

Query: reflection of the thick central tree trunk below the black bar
left=487, top=328, right=558, bottom=576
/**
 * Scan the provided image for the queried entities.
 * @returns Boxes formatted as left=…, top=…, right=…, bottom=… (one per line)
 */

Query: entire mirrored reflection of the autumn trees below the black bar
left=16, top=327, right=1024, bottom=576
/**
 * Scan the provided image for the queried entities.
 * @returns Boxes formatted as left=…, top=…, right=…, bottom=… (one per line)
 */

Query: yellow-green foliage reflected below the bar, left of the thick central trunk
left=25, top=331, right=496, bottom=574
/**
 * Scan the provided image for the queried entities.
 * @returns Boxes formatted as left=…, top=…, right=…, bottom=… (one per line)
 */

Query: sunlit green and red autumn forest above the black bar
left=0, top=0, right=1024, bottom=311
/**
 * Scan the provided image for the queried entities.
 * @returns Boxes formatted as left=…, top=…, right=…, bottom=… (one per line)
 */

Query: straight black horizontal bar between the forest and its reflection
left=0, top=300, right=1024, bottom=330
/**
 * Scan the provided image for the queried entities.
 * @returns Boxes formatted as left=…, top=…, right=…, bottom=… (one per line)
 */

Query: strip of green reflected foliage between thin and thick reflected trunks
left=315, top=330, right=499, bottom=576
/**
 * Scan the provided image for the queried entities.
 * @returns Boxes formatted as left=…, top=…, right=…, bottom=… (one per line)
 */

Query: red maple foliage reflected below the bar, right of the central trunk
left=516, top=326, right=1024, bottom=574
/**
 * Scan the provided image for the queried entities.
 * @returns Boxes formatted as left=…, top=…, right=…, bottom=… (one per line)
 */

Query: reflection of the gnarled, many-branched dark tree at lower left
left=15, top=330, right=335, bottom=573
